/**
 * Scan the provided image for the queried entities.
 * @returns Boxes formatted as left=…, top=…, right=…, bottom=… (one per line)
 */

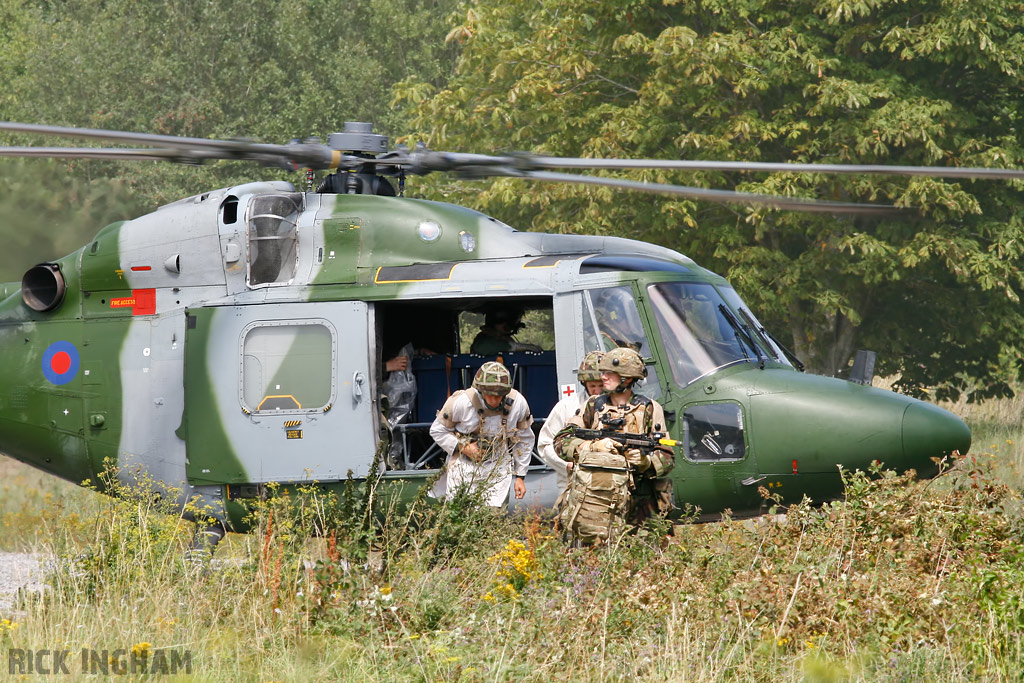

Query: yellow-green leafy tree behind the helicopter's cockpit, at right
left=399, top=0, right=1024, bottom=397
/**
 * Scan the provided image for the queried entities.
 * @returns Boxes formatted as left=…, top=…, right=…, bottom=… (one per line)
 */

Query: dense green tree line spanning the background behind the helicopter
left=0, top=0, right=1024, bottom=397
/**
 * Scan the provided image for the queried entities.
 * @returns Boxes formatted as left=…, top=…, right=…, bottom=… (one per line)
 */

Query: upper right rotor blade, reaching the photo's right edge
left=521, top=155, right=1024, bottom=180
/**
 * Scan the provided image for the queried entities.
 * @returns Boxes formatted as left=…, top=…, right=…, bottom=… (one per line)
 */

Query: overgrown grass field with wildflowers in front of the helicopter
left=0, top=399, right=1024, bottom=681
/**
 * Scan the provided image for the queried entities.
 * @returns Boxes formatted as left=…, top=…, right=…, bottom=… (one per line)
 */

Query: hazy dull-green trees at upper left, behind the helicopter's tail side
left=0, top=0, right=455, bottom=281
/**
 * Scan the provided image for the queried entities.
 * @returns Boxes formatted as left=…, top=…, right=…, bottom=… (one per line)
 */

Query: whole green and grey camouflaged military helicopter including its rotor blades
left=0, top=123, right=991, bottom=540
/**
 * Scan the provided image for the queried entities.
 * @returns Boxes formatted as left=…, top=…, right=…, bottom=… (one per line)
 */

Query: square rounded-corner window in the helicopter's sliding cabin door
left=240, top=319, right=337, bottom=413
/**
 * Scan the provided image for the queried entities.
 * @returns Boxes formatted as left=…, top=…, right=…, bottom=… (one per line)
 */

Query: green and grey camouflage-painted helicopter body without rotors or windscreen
left=0, top=182, right=970, bottom=523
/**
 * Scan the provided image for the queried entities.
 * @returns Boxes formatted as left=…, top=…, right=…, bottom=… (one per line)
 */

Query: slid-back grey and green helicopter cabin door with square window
left=183, top=301, right=377, bottom=484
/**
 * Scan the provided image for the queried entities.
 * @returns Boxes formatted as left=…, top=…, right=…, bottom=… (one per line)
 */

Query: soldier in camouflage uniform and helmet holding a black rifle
left=555, top=348, right=674, bottom=543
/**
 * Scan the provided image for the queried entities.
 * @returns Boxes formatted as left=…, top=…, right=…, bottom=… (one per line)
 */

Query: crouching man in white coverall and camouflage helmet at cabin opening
left=430, top=361, right=535, bottom=507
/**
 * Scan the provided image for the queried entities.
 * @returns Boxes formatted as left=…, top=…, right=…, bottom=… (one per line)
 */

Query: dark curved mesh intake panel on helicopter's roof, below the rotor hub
left=249, top=193, right=304, bottom=287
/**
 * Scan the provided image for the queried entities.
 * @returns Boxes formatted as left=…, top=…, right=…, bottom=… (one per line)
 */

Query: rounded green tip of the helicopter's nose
left=903, top=402, right=971, bottom=477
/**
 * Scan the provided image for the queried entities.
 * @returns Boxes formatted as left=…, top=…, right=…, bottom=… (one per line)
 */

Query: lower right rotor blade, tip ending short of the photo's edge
left=481, top=169, right=901, bottom=216
